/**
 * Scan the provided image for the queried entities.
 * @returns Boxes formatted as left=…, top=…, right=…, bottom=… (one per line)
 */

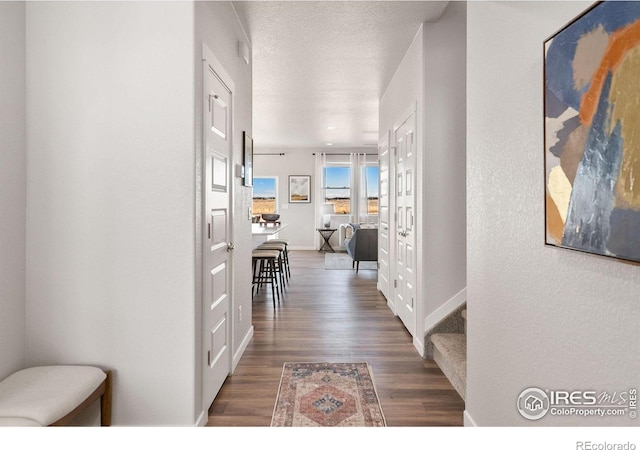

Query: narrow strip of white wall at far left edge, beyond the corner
left=0, top=2, right=26, bottom=379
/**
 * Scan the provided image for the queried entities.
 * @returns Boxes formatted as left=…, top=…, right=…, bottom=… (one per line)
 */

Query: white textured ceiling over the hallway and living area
left=233, top=0, right=447, bottom=151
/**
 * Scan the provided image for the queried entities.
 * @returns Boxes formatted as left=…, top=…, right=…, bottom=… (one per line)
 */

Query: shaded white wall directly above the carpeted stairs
left=420, top=1, right=467, bottom=320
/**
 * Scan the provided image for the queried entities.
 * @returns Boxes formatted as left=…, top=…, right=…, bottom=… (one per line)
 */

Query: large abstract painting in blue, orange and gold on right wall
left=544, top=1, right=640, bottom=264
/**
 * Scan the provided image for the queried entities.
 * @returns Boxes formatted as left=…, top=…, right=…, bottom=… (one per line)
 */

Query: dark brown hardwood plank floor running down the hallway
left=207, top=251, right=464, bottom=427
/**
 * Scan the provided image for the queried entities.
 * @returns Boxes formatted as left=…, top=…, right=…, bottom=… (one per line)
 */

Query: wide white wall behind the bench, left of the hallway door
left=26, top=2, right=195, bottom=425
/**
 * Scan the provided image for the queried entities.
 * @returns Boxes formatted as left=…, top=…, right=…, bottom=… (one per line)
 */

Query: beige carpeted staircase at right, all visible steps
left=425, top=304, right=467, bottom=400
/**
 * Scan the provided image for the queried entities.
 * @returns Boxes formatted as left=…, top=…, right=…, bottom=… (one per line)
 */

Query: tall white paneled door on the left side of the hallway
left=202, top=46, right=233, bottom=408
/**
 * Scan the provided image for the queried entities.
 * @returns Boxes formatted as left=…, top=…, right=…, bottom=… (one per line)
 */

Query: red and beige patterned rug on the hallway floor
left=271, top=362, right=386, bottom=427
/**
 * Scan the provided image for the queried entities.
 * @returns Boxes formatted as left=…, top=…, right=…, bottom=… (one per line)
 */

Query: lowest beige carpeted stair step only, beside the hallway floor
left=431, top=333, right=467, bottom=400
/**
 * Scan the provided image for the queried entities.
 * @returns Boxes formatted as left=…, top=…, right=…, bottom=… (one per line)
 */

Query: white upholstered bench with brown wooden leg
left=0, top=366, right=111, bottom=427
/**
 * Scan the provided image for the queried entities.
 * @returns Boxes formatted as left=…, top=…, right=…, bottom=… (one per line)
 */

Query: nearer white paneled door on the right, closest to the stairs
left=394, top=113, right=417, bottom=337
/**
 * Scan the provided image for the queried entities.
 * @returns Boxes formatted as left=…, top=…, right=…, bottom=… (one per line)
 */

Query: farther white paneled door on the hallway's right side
left=378, top=132, right=393, bottom=301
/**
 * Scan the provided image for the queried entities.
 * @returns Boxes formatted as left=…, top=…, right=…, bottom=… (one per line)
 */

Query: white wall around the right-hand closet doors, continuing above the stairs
left=380, top=2, right=466, bottom=353
